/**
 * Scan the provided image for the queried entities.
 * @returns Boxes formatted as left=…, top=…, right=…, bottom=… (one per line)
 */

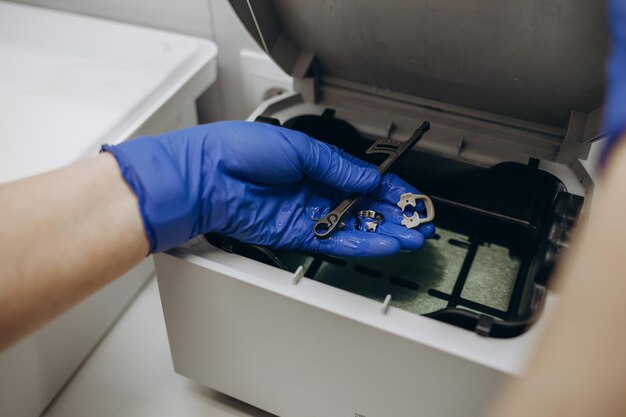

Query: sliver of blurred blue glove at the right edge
left=601, top=0, right=626, bottom=162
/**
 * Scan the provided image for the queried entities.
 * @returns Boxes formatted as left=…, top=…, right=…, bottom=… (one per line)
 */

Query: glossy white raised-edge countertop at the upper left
left=0, top=1, right=217, bottom=183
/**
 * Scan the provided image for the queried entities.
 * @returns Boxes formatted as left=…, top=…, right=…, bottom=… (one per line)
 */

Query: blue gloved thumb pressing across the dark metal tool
left=284, top=129, right=381, bottom=193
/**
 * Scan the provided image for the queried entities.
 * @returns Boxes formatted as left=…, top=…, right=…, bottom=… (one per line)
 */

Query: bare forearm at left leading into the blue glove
left=0, top=154, right=148, bottom=349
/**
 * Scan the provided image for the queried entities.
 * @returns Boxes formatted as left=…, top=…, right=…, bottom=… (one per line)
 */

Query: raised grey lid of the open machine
left=230, top=0, right=608, bottom=128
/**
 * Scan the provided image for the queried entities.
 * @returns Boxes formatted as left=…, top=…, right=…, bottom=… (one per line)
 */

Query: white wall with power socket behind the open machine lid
left=9, top=0, right=289, bottom=122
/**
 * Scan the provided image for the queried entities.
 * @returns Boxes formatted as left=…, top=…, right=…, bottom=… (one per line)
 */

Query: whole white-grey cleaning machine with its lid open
left=155, top=0, right=608, bottom=417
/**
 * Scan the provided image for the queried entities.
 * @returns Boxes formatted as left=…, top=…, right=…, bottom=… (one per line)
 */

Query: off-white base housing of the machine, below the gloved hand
left=154, top=93, right=572, bottom=417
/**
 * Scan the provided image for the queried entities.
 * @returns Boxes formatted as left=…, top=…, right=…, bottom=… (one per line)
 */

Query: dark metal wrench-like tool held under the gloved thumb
left=313, top=122, right=430, bottom=239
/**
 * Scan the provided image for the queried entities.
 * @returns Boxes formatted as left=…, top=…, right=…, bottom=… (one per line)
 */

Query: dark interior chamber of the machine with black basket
left=207, top=110, right=583, bottom=337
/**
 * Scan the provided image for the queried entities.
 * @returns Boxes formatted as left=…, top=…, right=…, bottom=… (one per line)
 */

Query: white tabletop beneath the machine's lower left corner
left=43, top=278, right=272, bottom=417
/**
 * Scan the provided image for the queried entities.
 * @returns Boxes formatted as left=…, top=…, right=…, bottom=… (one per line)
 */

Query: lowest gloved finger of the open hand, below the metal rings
left=309, top=230, right=402, bottom=258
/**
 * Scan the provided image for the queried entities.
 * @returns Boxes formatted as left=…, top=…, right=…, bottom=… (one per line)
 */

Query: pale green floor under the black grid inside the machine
left=277, top=224, right=520, bottom=314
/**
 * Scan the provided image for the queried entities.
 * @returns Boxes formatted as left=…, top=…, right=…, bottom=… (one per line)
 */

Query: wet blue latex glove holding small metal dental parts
left=103, top=122, right=434, bottom=256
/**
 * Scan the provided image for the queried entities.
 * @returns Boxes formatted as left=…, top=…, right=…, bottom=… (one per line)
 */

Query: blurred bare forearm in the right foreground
left=493, top=138, right=626, bottom=417
